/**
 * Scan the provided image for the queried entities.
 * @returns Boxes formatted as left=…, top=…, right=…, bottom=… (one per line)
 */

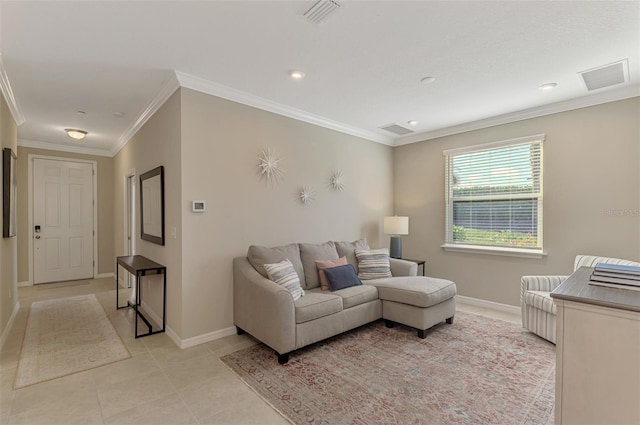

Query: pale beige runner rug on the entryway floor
left=13, top=294, right=131, bottom=389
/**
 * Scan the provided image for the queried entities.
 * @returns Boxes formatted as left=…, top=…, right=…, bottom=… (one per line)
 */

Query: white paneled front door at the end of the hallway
left=33, top=158, right=94, bottom=284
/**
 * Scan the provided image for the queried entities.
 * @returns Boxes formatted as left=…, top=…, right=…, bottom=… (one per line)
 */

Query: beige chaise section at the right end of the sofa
left=367, top=276, right=456, bottom=338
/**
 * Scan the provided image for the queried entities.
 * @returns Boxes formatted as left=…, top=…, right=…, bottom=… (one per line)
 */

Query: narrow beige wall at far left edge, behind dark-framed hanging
left=0, top=93, right=22, bottom=342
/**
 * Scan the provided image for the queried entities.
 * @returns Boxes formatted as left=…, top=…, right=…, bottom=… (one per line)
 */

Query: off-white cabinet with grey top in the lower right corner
left=552, top=267, right=640, bottom=425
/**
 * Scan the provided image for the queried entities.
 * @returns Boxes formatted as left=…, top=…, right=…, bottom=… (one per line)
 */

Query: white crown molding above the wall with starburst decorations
left=175, top=71, right=393, bottom=146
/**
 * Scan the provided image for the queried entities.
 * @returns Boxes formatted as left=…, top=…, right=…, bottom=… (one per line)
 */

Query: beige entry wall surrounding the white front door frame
left=17, top=146, right=115, bottom=283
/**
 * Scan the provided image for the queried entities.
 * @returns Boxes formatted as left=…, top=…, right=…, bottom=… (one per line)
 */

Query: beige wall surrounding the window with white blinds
left=394, top=97, right=640, bottom=305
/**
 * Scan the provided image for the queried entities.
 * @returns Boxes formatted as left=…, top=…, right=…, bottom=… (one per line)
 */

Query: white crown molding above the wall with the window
left=394, top=84, right=640, bottom=146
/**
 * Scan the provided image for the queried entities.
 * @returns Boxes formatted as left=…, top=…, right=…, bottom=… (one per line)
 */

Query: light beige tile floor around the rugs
left=0, top=278, right=520, bottom=425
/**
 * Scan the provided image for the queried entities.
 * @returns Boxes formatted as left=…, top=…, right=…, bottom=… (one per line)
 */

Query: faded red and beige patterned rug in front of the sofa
left=222, top=312, right=555, bottom=425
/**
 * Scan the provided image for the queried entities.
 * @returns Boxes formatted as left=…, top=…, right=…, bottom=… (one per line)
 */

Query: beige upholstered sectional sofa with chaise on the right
left=233, top=240, right=456, bottom=363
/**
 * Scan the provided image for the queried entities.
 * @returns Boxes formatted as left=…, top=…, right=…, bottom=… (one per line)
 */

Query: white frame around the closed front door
left=27, top=154, right=98, bottom=285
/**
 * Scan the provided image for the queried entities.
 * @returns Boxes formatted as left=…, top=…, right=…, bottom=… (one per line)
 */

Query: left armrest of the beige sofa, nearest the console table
left=233, top=257, right=296, bottom=354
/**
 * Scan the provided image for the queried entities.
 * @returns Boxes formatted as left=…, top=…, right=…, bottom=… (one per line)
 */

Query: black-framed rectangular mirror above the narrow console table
left=140, top=165, right=164, bottom=245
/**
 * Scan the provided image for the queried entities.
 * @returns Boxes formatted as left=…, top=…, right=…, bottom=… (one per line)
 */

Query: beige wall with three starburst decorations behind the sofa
left=181, top=89, right=393, bottom=338
